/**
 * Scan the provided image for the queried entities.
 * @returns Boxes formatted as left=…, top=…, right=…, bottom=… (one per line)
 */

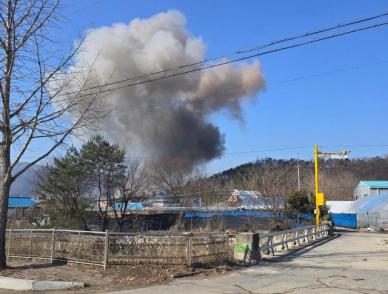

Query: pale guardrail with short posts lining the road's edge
left=252, top=224, right=330, bottom=258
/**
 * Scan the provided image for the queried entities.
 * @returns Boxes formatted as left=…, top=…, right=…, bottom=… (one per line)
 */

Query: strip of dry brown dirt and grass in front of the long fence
left=0, top=260, right=187, bottom=294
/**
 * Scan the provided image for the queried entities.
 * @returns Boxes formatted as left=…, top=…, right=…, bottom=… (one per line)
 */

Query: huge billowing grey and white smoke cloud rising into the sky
left=62, top=10, right=265, bottom=166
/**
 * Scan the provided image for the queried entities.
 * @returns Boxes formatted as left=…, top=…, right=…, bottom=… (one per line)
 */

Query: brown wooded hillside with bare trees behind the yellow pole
left=213, top=156, right=388, bottom=200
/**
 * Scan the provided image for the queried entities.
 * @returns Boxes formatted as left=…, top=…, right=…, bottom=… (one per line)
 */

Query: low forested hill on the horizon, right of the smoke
left=212, top=156, right=388, bottom=200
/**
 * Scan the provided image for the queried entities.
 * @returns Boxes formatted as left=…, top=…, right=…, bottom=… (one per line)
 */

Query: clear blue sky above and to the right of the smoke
left=23, top=0, right=388, bottom=173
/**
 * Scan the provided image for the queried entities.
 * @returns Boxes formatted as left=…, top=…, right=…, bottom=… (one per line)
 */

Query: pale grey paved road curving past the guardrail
left=110, top=233, right=388, bottom=294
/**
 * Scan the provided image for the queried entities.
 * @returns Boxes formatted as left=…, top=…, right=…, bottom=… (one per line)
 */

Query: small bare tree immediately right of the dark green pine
left=110, top=157, right=148, bottom=232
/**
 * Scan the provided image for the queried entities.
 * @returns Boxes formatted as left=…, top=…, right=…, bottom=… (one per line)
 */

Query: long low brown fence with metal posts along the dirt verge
left=6, top=229, right=232, bottom=268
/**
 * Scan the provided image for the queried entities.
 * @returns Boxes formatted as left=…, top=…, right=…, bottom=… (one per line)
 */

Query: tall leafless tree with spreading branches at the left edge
left=0, top=0, right=99, bottom=268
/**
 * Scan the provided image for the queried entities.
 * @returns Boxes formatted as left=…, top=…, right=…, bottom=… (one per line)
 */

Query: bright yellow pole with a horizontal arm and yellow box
left=314, top=145, right=350, bottom=225
